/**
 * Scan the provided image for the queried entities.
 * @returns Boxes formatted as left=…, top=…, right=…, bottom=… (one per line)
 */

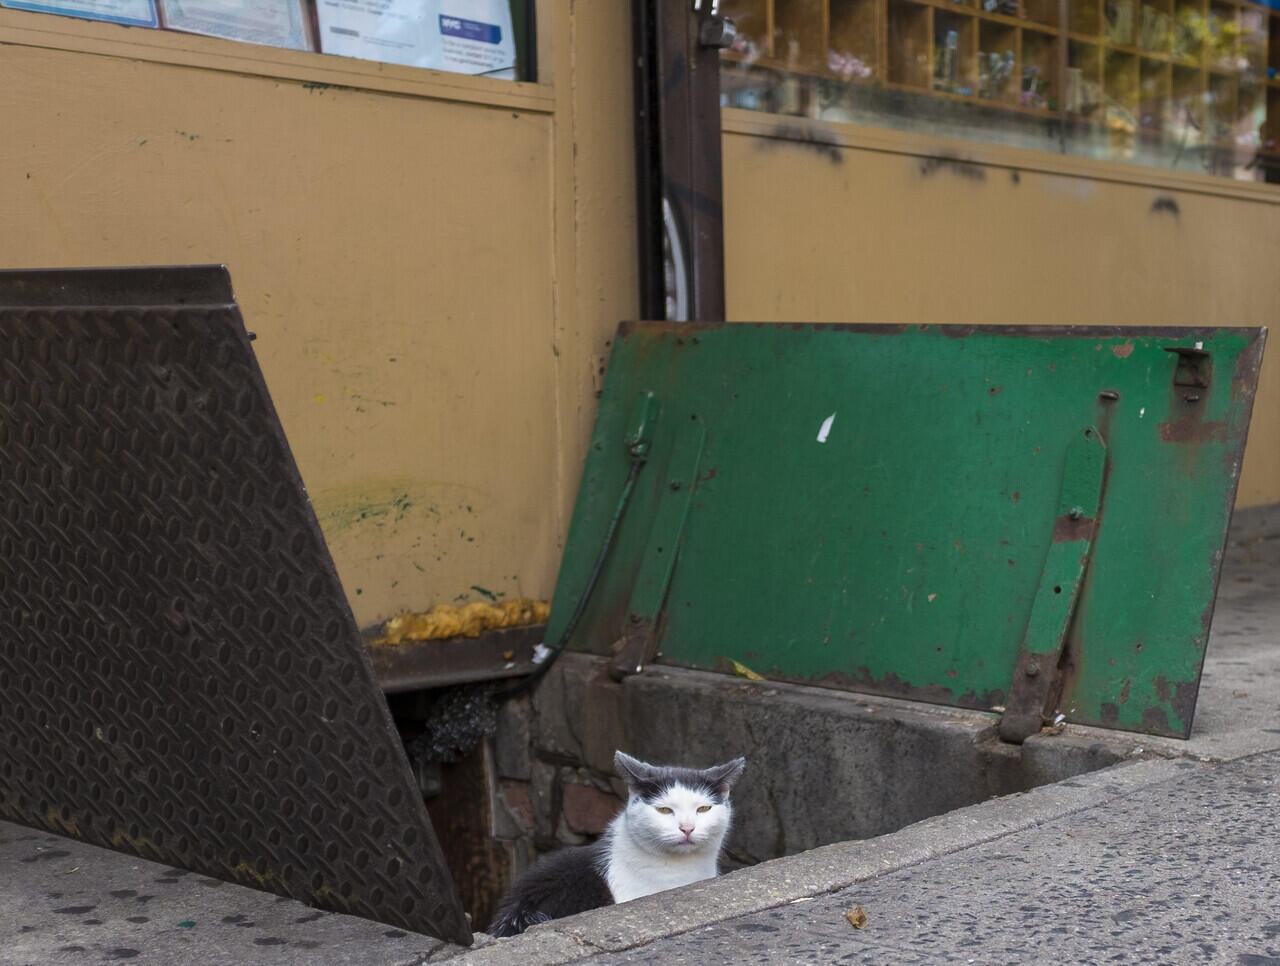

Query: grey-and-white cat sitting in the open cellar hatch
left=489, top=751, right=746, bottom=937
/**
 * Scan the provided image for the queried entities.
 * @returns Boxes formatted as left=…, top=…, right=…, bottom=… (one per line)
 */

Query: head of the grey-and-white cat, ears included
left=614, top=751, right=746, bottom=855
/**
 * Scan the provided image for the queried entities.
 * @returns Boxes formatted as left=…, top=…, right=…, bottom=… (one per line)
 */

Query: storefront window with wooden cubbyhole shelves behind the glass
left=721, top=0, right=1280, bottom=180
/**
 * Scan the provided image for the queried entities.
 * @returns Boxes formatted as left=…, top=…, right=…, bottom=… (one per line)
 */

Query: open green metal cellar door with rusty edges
left=547, top=322, right=1266, bottom=741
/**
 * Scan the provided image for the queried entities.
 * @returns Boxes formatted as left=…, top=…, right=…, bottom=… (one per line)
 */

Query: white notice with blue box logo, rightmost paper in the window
left=316, top=0, right=516, bottom=78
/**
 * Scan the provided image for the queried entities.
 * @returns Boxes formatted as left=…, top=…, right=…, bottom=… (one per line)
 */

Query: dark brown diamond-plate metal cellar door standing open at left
left=0, top=264, right=470, bottom=942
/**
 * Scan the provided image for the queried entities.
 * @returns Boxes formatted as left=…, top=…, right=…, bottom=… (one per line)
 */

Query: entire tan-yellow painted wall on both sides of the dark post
left=0, top=0, right=1280, bottom=634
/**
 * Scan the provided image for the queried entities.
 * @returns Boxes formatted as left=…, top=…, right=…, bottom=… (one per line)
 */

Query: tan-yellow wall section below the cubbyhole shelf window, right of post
left=723, top=111, right=1280, bottom=505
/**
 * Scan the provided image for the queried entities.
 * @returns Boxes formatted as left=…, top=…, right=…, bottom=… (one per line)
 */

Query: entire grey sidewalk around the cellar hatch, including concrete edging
left=0, top=514, right=1280, bottom=966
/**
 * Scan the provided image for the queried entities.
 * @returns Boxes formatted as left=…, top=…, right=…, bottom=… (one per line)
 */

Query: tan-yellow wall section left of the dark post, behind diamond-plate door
left=0, top=4, right=636, bottom=624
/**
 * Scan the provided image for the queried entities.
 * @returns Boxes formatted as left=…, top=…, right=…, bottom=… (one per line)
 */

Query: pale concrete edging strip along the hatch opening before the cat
left=456, top=759, right=1208, bottom=966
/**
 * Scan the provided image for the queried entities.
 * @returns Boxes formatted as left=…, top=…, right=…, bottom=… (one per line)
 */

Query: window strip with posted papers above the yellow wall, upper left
left=0, top=0, right=536, bottom=81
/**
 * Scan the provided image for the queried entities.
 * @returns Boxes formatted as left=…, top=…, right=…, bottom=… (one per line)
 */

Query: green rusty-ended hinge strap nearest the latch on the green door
left=1000, top=426, right=1107, bottom=745
